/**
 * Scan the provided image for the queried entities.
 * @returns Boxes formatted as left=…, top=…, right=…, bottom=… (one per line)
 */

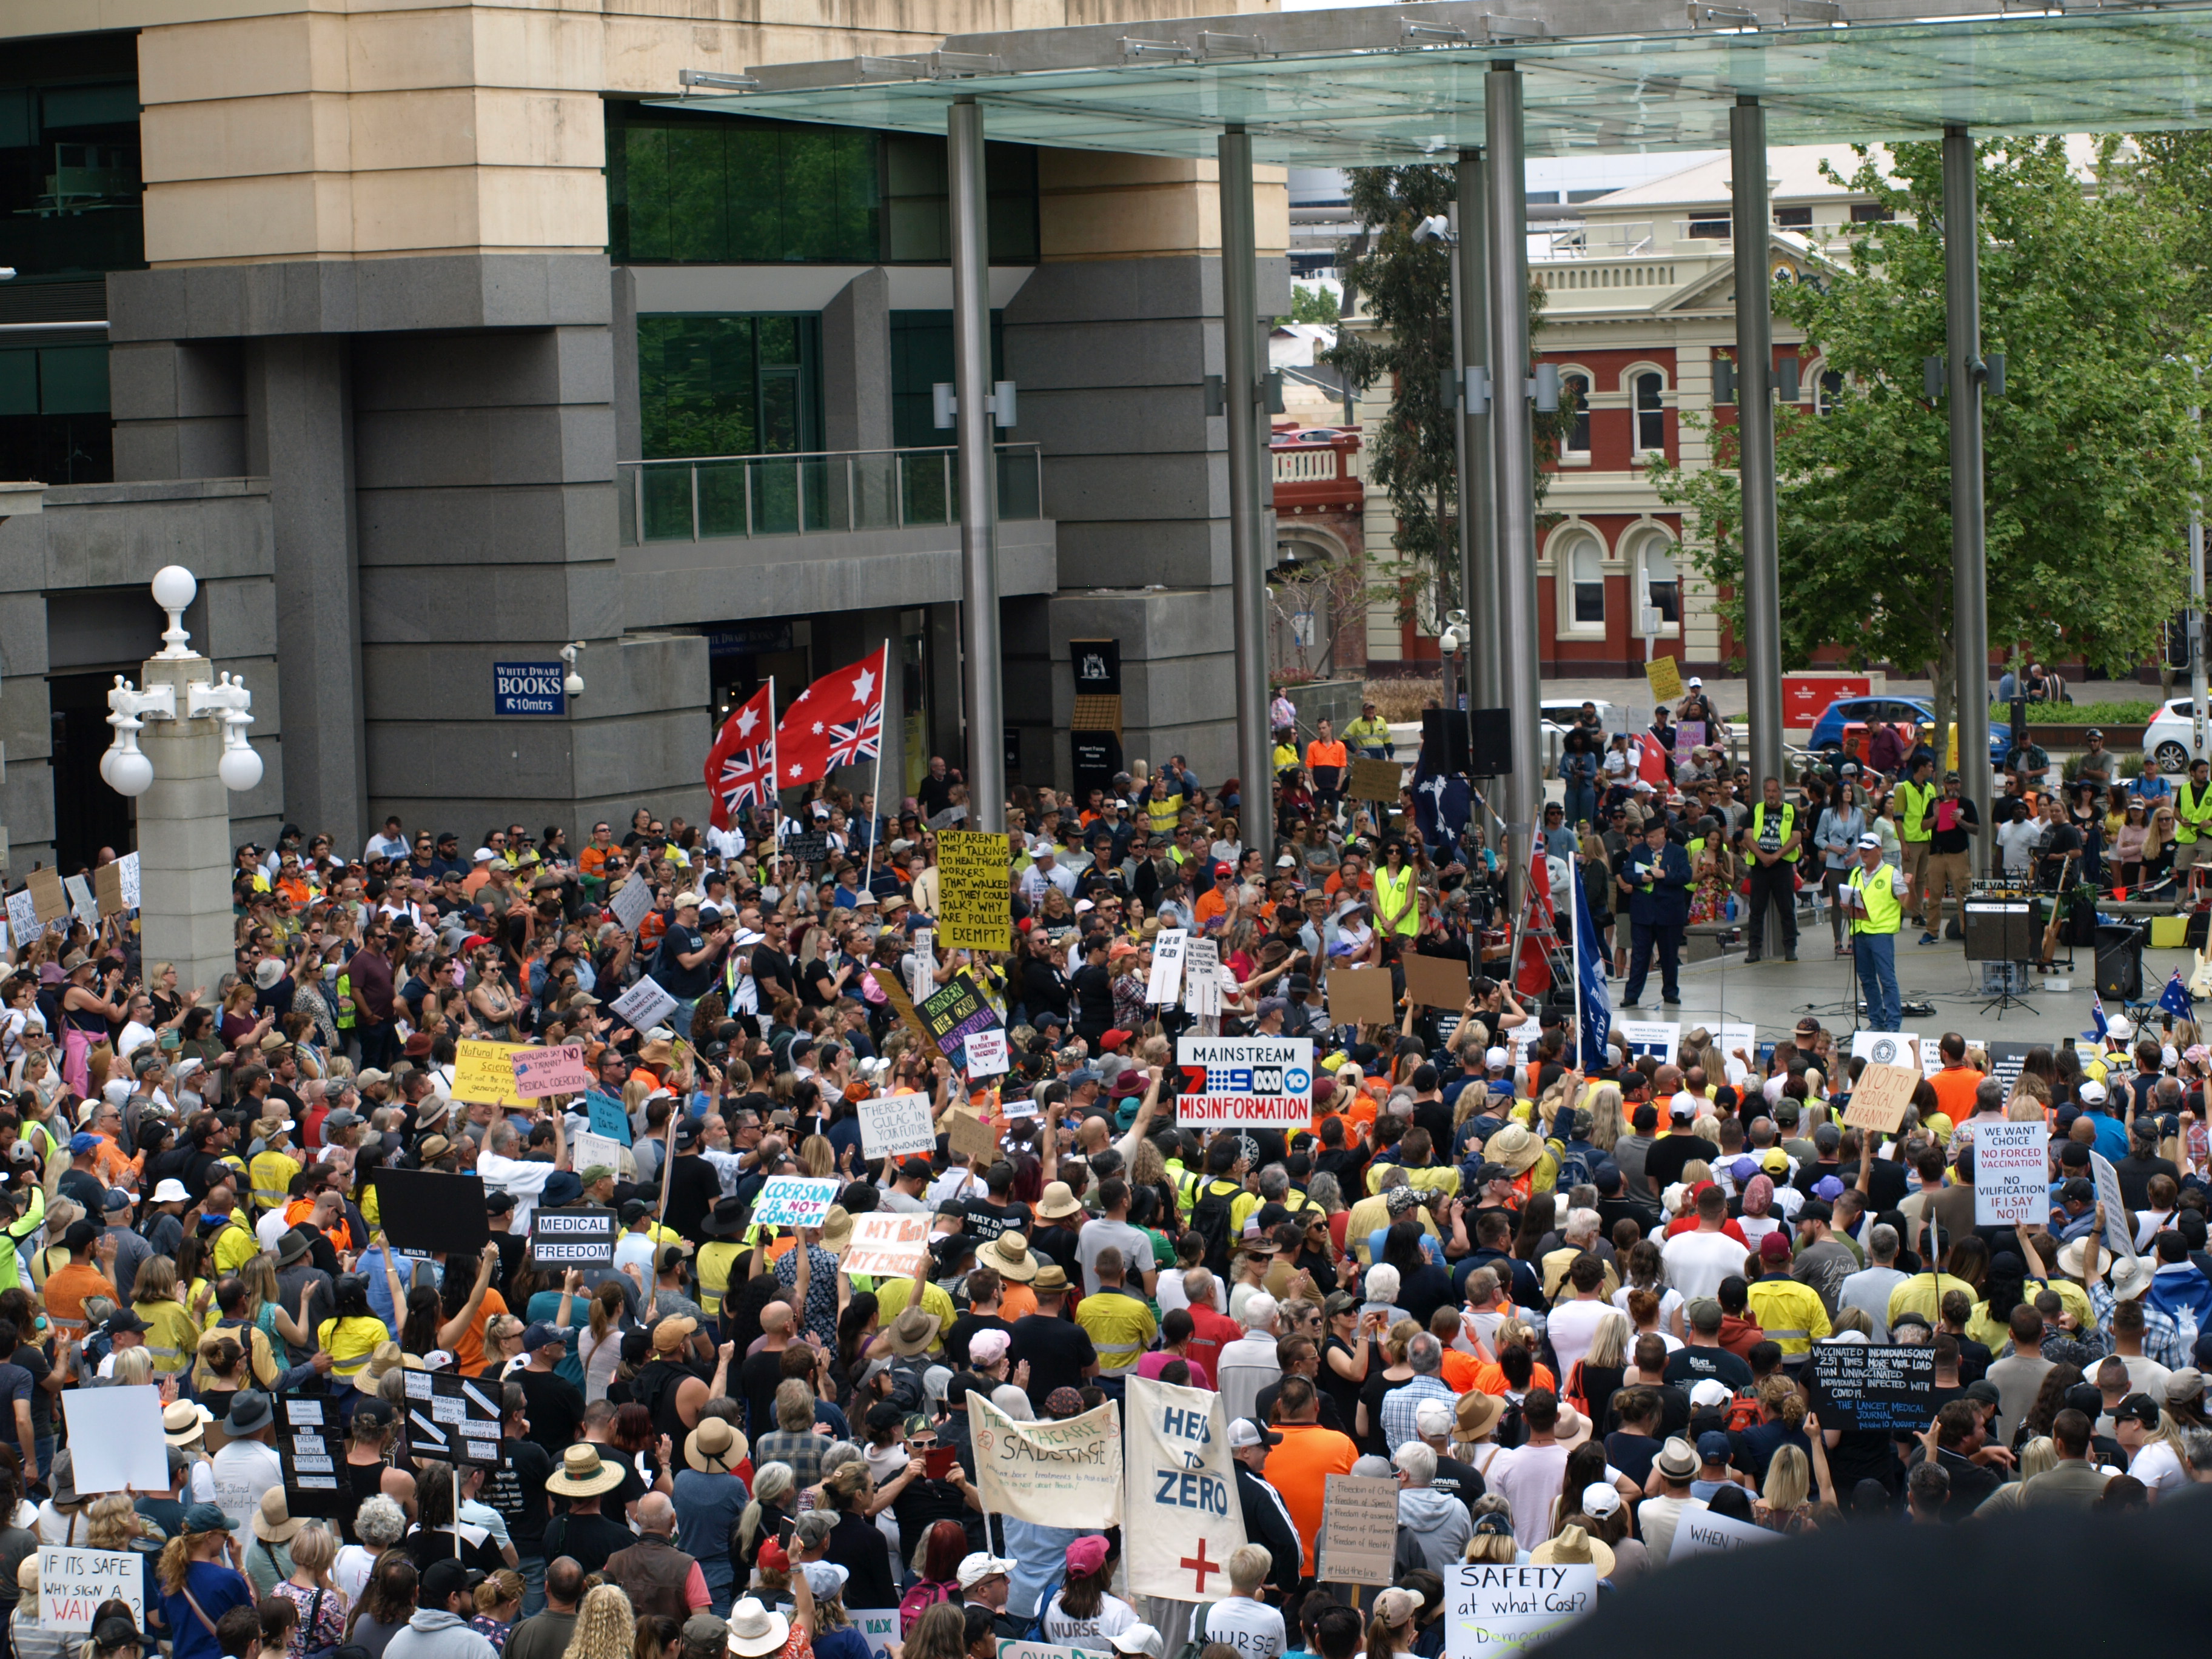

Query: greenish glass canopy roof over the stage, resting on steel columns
left=666, top=0, right=2212, bottom=166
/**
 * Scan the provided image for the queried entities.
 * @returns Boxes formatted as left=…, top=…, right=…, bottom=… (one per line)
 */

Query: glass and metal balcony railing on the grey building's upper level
left=619, top=444, right=1044, bottom=546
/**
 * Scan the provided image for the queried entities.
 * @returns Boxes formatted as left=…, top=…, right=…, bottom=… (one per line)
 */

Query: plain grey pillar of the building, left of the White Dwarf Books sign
left=246, top=334, right=367, bottom=851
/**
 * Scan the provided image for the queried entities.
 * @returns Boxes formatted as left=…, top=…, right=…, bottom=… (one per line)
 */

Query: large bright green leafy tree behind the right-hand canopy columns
left=1652, top=139, right=2201, bottom=748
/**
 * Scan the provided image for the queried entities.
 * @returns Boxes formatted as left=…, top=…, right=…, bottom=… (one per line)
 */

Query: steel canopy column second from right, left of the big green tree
left=1728, top=98, right=1783, bottom=788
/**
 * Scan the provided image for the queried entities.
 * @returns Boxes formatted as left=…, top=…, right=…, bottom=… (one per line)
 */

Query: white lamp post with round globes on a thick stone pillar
left=99, top=564, right=261, bottom=1008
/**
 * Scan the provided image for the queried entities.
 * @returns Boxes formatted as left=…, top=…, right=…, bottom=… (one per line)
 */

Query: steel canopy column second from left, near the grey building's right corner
left=1219, top=126, right=1274, bottom=860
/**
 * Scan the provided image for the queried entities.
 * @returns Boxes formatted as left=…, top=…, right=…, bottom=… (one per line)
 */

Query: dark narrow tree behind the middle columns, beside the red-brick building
left=1321, top=166, right=1573, bottom=632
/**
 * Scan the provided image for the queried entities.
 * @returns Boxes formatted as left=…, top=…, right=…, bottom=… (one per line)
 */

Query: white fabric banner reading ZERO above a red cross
left=1124, top=1376, right=1245, bottom=1601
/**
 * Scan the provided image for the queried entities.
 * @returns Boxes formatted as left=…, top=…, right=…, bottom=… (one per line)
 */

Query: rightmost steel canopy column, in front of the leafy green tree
left=1936, top=126, right=1997, bottom=870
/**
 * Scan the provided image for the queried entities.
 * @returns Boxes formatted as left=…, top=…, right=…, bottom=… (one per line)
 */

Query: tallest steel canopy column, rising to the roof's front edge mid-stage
left=1482, top=64, right=1544, bottom=918
